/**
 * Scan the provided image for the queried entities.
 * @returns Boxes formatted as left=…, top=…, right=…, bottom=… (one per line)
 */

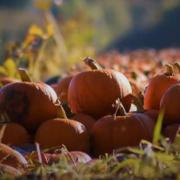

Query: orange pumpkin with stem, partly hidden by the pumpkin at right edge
left=144, top=66, right=178, bottom=110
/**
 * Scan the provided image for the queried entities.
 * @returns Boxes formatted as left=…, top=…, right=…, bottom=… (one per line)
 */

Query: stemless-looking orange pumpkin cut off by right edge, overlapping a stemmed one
left=160, top=83, right=180, bottom=124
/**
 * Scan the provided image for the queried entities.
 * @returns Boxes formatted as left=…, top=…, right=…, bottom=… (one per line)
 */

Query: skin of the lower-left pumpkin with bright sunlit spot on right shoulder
left=35, top=118, right=89, bottom=152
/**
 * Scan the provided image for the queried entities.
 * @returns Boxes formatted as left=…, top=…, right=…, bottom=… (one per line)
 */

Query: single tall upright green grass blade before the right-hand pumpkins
left=153, top=109, right=164, bottom=144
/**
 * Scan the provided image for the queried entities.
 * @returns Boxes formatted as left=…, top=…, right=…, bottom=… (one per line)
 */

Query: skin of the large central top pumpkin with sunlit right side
left=68, top=70, right=132, bottom=118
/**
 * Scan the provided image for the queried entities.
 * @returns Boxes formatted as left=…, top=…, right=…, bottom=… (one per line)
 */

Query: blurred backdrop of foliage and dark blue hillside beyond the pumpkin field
left=0, top=0, right=180, bottom=78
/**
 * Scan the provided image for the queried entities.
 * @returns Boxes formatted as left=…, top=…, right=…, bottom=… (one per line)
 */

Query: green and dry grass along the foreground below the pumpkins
left=1, top=111, right=180, bottom=180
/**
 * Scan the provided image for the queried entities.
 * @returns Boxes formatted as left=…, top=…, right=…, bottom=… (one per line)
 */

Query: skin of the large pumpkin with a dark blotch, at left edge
left=0, top=82, right=57, bottom=131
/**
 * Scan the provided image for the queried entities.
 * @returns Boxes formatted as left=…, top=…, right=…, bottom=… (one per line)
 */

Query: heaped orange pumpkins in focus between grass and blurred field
left=0, top=55, right=180, bottom=174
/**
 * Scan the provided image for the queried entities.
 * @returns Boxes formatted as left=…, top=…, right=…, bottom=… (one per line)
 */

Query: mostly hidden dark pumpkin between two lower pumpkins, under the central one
left=72, top=113, right=96, bottom=132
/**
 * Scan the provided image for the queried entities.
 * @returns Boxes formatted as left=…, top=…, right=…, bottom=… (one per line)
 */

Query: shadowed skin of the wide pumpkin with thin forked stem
left=92, top=113, right=154, bottom=156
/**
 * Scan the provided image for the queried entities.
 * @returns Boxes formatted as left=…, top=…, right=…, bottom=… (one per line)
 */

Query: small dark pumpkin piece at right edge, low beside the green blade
left=163, top=124, right=180, bottom=142
